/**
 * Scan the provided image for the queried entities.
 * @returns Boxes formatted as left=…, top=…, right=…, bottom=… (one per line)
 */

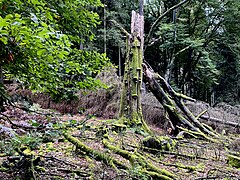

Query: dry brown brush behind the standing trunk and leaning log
left=6, top=69, right=240, bottom=132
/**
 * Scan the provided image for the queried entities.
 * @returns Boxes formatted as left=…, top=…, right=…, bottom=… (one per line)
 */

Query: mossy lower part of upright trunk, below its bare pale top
left=119, top=31, right=151, bottom=133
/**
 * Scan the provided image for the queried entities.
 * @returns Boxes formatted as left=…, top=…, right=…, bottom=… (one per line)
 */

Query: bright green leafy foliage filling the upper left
left=0, top=0, right=110, bottom=99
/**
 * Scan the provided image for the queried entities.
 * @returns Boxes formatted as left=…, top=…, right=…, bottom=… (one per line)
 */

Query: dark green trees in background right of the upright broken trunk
left=145, top=0, right=240, bottom=102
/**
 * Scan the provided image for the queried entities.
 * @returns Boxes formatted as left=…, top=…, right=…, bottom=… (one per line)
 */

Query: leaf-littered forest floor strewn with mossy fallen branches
left=0, top=100, right=240, bottom=180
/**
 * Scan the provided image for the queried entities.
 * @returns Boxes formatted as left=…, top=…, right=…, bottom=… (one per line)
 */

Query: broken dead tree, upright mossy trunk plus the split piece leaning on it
left=118, top=8, right=218, bottom=139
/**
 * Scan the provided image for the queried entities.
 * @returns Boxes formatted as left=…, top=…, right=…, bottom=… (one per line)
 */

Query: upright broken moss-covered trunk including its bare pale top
left=120, top=11, right=149, bottom=131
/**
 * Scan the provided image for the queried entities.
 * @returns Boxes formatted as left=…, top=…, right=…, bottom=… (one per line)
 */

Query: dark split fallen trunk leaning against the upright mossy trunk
left=143, top=64, right=218, bottom=138
